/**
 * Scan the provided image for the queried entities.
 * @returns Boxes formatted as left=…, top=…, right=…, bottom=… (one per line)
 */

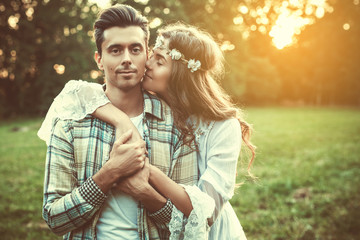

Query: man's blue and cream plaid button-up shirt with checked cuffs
left=43, top=93, right=198, bottom=239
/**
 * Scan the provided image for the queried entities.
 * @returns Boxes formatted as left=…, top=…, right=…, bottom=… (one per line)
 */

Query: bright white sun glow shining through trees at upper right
left=233, top=0, right=332, bottom=49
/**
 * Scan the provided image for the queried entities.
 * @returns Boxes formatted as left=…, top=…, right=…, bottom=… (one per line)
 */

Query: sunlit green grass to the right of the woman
left=231, top=108, right=360, bottom=240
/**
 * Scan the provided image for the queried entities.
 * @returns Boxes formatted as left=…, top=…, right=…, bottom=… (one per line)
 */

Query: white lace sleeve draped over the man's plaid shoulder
left=37, top=80, right=110, bottom=145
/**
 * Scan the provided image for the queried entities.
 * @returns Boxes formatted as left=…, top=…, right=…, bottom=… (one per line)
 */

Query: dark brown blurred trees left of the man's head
left=0, top=0, right=98, bottom=116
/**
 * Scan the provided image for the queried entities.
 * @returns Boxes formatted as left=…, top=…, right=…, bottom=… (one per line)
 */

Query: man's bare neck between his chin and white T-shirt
left=105, top=87, right=144, bottom=118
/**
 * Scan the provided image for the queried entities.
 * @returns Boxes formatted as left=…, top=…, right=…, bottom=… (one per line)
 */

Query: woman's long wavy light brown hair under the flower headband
left=158, top=23, right=255, bottom=171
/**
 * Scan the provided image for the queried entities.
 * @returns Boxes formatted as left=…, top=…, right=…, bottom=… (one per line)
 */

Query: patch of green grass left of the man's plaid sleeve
left=0, top=119, right=59, bottom=239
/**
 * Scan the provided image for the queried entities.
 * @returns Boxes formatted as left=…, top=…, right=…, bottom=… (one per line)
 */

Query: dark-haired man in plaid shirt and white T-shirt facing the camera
left=43, top=5, right=197, bottom=239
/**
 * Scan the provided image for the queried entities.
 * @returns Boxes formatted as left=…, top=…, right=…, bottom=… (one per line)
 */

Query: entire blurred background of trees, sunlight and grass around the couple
left=0, top=0, right=360, bottom=240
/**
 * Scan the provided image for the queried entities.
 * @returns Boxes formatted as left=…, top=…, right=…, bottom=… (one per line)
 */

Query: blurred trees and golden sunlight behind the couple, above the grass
left=0, top=0, right=360, bottom=118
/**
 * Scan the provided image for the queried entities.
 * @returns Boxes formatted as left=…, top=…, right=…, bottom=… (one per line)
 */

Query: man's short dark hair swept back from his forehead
left=94, top=4, right=150, bottom=56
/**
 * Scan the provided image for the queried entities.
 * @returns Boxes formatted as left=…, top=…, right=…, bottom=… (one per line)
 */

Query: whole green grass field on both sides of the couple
left=0, top=108, right=360, bottom=240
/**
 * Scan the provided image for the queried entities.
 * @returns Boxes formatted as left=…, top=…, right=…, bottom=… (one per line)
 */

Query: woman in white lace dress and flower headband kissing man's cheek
left=38, top=24, right=254, bottom=239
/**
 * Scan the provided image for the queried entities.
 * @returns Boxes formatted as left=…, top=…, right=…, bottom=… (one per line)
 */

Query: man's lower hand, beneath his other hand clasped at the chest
left=114, top=158, right=150, bottom=201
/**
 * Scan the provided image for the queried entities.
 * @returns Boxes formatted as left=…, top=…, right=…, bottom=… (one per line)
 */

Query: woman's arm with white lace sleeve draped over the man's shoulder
left=38, top=80, right=141, bottom=145
